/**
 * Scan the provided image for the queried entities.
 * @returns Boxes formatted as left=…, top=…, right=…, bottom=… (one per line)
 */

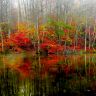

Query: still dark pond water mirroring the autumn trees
left=0, top=52, right=96, bottom=96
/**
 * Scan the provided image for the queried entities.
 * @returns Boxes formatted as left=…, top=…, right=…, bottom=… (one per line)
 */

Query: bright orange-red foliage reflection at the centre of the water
left=41, top=55, right=64, bottom=76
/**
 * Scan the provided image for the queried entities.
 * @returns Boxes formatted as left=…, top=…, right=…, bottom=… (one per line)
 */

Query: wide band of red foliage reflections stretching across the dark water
left=5, top=55, right=96, bottom=79
